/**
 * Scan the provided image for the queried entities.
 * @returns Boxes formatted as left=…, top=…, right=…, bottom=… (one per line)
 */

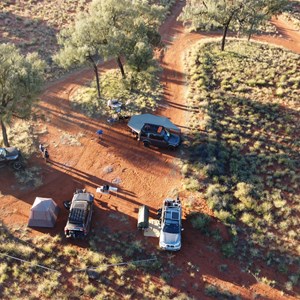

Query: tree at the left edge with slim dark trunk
left=0, top=44, right=46, bottom=147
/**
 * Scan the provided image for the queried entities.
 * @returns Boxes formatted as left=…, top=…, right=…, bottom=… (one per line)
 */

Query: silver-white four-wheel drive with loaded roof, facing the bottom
left=159, top=198, right=183, bottom=251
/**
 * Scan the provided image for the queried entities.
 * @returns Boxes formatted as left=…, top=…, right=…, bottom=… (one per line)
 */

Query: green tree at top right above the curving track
left=179, top=0, right=286, bottom=51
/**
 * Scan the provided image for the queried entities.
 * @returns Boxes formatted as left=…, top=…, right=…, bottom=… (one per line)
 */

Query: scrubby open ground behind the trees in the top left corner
left=0, top=0, right=174, bottom=78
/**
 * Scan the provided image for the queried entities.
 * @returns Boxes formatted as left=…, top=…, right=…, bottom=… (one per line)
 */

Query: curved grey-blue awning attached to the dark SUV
left=128, top=114, right=181, bottom=134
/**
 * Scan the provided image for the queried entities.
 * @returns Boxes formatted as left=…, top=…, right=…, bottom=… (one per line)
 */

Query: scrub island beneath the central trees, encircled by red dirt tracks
left=71, top=68, right=162, bottom=117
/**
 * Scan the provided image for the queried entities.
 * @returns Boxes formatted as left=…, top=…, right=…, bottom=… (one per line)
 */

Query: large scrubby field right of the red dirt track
left=183, top=40, right=300, bottom=292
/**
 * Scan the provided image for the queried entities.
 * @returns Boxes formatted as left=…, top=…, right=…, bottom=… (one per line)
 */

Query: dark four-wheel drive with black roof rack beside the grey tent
left=65, top=190, right=94, bottom=238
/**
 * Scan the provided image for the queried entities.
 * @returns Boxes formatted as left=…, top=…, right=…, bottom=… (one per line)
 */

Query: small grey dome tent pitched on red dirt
left=28, top=197, right=59, bottom=227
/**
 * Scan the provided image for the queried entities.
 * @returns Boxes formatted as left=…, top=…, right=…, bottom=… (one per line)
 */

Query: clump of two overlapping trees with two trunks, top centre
left=54, top=0, right=165, bottom=91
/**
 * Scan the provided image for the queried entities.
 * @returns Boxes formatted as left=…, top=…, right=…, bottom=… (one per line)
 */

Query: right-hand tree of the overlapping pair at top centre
left=90, top=0, right=165, bottom=78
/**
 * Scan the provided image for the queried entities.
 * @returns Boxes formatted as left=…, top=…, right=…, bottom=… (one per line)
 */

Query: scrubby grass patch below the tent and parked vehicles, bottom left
left=0, top=223, right=183, bottom=299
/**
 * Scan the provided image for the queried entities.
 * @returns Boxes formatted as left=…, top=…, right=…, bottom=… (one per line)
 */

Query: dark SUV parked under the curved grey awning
left=139, top=124, right=180, bottom=150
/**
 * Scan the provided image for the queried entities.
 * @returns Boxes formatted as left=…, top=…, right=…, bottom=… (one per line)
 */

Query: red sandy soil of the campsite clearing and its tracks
left=0, top=1, right=300, bottom=299
